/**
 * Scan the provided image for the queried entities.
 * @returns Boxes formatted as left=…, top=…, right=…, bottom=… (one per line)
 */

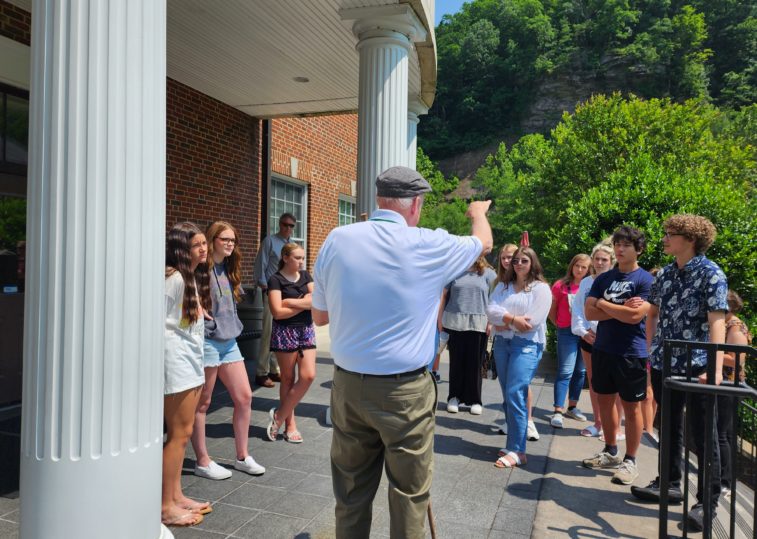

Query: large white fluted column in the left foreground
left=21, top=0, right=171, bottom=539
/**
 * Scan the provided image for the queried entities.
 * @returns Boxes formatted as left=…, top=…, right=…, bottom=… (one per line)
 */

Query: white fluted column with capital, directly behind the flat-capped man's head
left=340, top=4, right=426, bottom=215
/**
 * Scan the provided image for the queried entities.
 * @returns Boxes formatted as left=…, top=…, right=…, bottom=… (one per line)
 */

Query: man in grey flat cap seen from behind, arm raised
left=312, top=167, right=492, bottom=539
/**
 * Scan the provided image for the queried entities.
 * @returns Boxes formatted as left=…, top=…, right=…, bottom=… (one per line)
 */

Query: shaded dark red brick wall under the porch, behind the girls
left=166, top=79, right=263, bottom=283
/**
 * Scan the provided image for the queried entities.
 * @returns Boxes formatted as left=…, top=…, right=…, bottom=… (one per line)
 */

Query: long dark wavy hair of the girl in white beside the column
left=166, top=221, right=211, bottom=324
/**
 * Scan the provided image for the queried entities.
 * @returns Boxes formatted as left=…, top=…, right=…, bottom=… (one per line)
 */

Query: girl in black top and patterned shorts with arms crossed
left=266, top=243, right=315, bottom=444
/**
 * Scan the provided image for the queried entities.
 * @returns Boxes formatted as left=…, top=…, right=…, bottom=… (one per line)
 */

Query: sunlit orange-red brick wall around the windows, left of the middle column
left=271, top=114, right=357, bottom=268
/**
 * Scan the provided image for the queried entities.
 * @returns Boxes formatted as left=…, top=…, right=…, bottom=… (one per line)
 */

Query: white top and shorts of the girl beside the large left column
left=163, top=271, right=205, bottom=395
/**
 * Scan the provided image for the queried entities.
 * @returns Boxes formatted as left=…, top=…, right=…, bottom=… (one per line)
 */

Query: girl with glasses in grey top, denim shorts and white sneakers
left=192, top=221, right=265, bottom=480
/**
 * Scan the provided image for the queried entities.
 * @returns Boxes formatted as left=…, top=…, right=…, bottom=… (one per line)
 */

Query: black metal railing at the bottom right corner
left=659, top=340, right=757, bottom=539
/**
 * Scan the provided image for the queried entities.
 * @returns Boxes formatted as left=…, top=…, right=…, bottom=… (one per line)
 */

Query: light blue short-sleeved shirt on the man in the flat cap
left=313, top=210, right=482, bottom=374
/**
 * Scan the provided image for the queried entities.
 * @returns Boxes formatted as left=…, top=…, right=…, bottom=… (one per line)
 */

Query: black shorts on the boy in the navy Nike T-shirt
left=591, top=348, right=647, bottom=402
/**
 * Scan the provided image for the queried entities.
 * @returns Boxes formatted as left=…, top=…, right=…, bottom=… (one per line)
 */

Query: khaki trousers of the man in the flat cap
left=331, top=369, right=436, bottom=539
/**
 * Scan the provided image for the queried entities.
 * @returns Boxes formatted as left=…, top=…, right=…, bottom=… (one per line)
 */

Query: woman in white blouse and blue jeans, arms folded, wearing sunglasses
left=486, top=247, right=552, bottom=468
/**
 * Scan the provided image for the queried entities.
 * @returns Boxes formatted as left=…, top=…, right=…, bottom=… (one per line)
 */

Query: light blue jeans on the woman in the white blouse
left=494, top=337, right=543, bottom=453
